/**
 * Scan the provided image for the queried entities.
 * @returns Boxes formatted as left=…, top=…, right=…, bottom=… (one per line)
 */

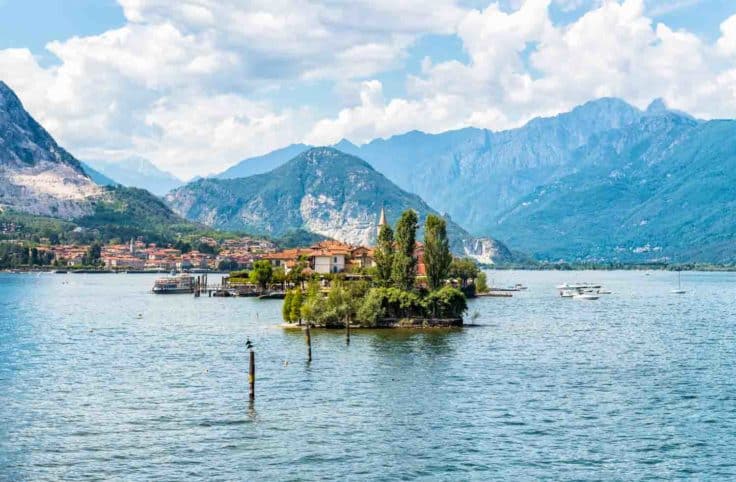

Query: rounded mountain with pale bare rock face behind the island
left=165, top=147, right=510, bottom=262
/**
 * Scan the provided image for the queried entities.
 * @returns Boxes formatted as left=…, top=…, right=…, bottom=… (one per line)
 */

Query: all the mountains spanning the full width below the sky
left=0, top=76, right=736, bottom=263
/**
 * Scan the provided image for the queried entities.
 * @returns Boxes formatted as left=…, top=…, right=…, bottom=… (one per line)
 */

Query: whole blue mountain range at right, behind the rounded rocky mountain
left=208, top=98, right=736, bottom=262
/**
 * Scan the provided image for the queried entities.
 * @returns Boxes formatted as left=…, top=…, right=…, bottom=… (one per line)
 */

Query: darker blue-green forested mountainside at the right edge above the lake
left=496, top=114, right=736, bottom=263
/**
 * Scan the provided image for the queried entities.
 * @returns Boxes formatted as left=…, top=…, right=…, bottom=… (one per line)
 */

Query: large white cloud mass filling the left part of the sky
left=0, top=0, right=462, bottom=175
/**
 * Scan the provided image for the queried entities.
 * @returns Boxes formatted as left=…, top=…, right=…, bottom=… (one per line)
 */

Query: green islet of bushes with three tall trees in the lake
left=283, top=210, right=487, bottom=328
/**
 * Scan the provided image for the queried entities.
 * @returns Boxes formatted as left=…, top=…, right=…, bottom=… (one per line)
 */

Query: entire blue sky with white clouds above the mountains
left=0, top=0, right=736, bottom=177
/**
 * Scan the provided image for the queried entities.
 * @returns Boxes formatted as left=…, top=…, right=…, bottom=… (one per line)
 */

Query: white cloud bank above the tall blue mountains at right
left=311, top=0, right=736, bottom=142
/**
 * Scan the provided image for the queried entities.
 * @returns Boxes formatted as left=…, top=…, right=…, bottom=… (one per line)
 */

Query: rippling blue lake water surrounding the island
left=0, top=272, right=736, bottom=480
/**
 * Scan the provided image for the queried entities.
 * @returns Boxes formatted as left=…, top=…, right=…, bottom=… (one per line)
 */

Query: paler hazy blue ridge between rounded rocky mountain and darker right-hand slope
left=217, top=98, right=642, bottom=235
